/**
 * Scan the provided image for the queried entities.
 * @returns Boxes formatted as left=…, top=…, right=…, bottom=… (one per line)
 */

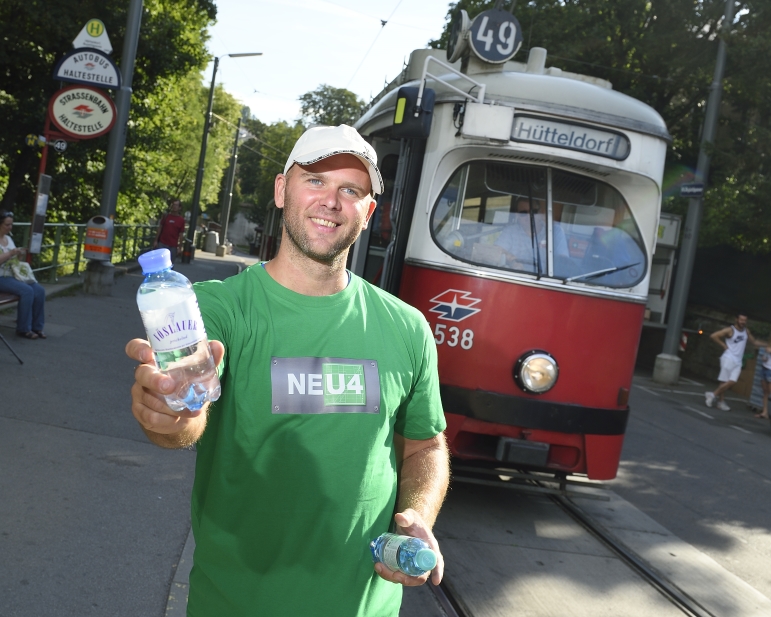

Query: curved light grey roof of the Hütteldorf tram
left=356, top=50, right=671, bottom=141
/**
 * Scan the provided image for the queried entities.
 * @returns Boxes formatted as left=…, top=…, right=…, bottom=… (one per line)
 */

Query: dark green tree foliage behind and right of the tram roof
left=429, top=0, right=771, bottom=254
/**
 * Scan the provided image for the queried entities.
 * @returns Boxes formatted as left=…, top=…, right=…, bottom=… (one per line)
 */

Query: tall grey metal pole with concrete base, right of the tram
left=653, top=0, right=735, bottom=383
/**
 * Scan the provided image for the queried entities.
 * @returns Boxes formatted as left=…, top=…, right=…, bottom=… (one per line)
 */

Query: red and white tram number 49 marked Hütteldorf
left=351, top=11, right=670, bottom=479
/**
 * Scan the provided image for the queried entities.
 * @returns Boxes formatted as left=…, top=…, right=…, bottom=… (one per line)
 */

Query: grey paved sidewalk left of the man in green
left=0, top=252, right=256, bottom=617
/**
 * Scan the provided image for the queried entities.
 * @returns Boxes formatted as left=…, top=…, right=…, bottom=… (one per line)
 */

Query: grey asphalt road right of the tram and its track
left=620, top=376, right=771, bottom=598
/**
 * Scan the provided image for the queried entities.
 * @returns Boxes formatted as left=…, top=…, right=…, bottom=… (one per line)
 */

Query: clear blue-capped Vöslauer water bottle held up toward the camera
left=137, top=249, right=220, bottom=411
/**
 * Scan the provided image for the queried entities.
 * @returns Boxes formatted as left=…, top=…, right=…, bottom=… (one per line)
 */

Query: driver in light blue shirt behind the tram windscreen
left=495, top=196, right=569, bottom=274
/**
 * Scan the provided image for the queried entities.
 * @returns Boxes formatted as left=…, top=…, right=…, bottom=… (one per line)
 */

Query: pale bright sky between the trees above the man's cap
left=204, top=0, right=450, bottom=124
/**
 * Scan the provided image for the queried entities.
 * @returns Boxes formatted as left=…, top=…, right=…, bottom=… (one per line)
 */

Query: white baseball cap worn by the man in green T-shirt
left=284, top=124, right=383, bottom=195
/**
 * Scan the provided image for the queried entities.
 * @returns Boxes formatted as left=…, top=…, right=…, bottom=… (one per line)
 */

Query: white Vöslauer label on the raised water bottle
left=140, top=295, right=206, bottom=353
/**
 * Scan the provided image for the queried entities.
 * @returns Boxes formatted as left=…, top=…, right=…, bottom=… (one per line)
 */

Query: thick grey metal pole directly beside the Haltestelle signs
left=99, top=0, right=142, bottom=218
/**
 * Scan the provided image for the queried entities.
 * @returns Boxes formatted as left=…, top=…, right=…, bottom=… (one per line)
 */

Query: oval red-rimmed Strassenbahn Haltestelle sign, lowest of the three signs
left=48, top=86, right=116, bottom=139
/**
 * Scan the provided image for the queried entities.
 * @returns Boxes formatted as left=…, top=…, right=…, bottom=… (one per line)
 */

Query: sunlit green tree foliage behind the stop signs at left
left=0, top=0, right=232, bottom=222
